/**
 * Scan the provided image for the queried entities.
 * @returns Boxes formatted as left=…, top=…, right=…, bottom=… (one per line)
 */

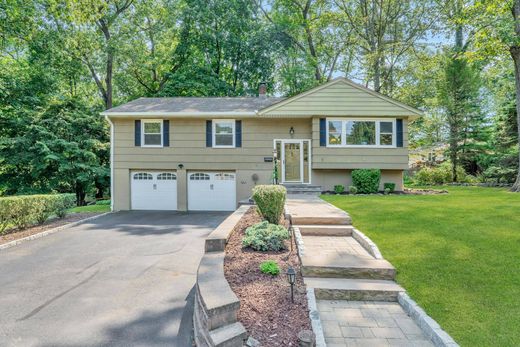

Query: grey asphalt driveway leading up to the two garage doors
left=0, top=211, right=228, bottom=347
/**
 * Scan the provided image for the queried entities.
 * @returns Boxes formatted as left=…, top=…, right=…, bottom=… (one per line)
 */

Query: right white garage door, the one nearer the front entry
left=188, top=172, right=236, bottom=211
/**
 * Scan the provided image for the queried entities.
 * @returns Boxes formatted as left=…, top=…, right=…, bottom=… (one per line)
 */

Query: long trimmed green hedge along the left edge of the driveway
left=0, top=194, right=76, bottom=234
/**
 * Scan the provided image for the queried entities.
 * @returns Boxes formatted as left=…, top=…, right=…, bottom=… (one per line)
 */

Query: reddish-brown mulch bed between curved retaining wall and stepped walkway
left=224, top=207, right=311, bottom=346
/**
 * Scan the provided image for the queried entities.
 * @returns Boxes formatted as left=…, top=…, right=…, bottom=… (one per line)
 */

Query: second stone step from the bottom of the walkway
left=301, top=254, right=395, bottom=280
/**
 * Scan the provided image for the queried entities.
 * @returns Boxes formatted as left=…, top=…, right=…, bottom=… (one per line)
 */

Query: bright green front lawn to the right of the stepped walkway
left=322, top=187, right=520, bottom=346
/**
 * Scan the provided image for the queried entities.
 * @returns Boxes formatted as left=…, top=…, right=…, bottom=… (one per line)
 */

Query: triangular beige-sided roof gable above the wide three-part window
left=258, top=77, right=422, bottom=118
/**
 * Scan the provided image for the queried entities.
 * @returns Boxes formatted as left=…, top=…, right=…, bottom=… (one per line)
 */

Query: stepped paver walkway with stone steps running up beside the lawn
left=286, top=194, right=433, bottom=347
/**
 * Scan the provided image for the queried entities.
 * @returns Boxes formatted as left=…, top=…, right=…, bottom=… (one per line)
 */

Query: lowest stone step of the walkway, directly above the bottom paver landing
left=304, top=277, right=404, bottom=301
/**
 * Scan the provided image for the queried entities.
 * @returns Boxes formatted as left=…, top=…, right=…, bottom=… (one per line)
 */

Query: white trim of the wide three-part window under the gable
left=325, top=117, right=397, bottom=148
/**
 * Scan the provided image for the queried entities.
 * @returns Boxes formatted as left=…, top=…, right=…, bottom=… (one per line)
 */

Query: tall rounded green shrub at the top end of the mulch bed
left=253, top=185, right=287, bottom=224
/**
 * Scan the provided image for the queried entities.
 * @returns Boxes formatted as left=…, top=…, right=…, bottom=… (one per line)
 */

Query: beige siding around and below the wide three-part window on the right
left=312, top=117, right=408, bottom=170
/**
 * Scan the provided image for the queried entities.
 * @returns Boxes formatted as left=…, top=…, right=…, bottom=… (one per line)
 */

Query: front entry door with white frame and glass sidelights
left=275, top=140, right=311, bottom=183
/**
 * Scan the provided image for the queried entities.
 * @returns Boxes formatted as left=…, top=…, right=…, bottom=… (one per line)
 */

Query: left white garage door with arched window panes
left=131, top=171, right=177, bottom=210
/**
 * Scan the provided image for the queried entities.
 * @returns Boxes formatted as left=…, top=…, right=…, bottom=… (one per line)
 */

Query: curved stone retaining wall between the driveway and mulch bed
left=193, top=206, right=250, bottom=347
